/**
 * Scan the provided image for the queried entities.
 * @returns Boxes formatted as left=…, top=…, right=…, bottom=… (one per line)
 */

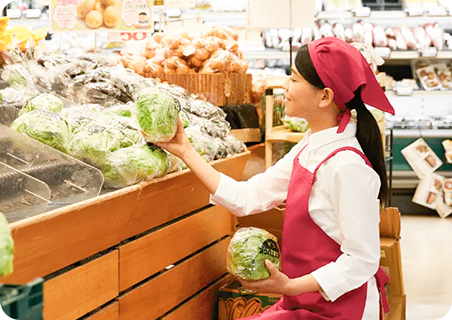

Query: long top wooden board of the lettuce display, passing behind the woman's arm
left=1, top=151, right=249, bottom=283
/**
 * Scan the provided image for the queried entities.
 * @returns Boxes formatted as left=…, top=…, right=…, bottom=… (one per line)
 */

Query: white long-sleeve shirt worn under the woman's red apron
left=211, top=123, right=380, bottom=320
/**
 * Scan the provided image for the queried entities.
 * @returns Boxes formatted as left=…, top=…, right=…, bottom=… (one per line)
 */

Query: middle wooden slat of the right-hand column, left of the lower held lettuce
left=119, top=238, right=229, bottom=320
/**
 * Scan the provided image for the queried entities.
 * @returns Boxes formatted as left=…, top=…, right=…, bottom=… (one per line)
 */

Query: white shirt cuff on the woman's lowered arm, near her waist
left=311, top=262, right=349, bottom=302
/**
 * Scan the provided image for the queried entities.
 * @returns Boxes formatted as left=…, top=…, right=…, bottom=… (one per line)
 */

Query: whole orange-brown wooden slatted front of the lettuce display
left=1, top=151, right=250, bottom=320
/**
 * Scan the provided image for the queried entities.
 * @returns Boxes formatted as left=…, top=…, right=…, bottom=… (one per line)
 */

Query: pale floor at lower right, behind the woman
left=401, top=215, right=452, bottom=320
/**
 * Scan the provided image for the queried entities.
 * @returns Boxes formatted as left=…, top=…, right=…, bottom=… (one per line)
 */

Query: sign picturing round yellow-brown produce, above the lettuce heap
left=51, top=0, right=153, bottom=32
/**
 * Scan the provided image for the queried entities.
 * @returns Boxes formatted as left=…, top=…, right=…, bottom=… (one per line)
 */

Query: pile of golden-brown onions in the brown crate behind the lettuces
left=121, top=27, right=248, bottom=78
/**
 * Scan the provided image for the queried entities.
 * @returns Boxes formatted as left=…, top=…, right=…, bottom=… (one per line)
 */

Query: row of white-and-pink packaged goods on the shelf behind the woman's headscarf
left=263, top=21, right=452, bottom=51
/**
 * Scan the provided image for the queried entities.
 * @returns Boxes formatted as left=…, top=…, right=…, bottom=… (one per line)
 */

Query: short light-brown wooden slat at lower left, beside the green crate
left=44, top=250, right=119, bottom=320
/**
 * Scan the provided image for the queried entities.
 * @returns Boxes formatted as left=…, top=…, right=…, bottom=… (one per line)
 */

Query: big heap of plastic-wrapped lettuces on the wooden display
left=0, top=55, right=246, bottom=188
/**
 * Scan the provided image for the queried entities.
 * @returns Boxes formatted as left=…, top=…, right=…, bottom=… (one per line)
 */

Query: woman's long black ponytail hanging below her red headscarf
left=345, top=88, right=388, bottom=207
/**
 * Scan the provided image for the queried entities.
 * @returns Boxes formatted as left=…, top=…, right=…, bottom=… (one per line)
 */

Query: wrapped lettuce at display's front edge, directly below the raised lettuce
left=102, top=144, right=169, bottom=188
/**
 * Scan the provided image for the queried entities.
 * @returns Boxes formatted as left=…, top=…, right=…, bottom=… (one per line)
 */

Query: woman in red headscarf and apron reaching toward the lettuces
left=161, top=38, right=394, bottom=320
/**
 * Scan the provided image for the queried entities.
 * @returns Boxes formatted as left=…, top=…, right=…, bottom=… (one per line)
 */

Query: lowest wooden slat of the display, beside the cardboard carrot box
left=162, top=275, right=233, bottom=320
